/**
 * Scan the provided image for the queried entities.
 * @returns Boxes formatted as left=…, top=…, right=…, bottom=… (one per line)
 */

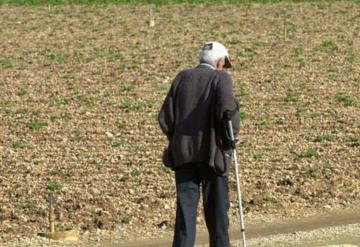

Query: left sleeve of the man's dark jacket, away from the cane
left=158, top=74, right=180, bottom=140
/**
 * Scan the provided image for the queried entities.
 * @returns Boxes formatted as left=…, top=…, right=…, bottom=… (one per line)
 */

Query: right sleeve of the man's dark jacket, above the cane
left=216, top=71, right=240, bottom=135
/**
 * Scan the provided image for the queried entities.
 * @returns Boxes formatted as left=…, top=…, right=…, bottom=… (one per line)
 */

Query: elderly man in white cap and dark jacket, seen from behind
left=158, top=42, right=239, bottom=247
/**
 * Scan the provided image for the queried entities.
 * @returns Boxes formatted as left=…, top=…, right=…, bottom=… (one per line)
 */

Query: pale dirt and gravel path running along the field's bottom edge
left=0, top=209, right=360, bottom=247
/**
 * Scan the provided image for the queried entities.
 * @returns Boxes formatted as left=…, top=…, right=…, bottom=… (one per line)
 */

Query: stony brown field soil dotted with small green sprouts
left=0, top=2, right=360, bottom=242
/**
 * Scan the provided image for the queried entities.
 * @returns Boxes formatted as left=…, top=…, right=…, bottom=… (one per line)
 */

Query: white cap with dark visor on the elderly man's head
left=200, top=41, right=232, bottom=68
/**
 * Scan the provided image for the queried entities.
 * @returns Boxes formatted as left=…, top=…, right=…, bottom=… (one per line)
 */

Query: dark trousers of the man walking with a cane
left=173, top=163, right=230, bottom=247
